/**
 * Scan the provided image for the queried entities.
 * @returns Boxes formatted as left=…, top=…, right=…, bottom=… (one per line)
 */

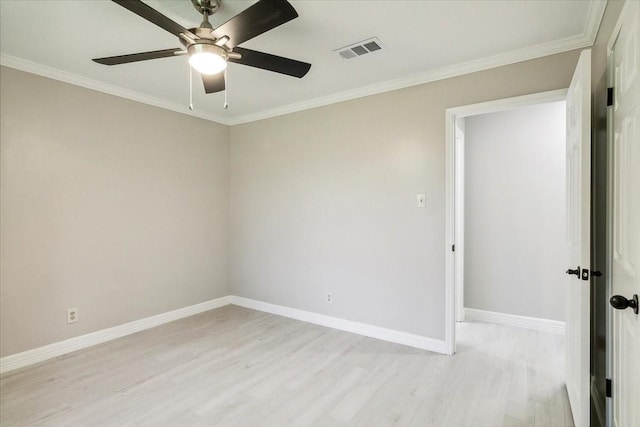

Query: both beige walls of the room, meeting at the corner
left=0, top=45, right=592, bottom=356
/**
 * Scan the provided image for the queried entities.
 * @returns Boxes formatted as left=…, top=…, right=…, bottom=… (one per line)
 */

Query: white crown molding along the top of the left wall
left=0, top=53, right=228, bottom=125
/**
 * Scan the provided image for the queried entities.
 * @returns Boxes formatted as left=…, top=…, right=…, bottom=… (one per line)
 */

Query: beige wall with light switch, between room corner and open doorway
left=230, top=51, right=578, bottom=339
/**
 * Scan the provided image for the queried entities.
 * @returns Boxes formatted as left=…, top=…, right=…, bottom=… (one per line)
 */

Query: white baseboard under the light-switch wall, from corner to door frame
left=230, top=296, right=447, bottom=354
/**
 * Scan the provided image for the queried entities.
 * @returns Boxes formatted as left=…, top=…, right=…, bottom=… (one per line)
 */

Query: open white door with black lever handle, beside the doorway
left=565, top=50, right=591, bottom=427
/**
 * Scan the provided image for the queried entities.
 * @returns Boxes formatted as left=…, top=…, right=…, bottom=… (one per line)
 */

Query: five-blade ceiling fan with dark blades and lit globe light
left=93, top=0, right=311, bottom=93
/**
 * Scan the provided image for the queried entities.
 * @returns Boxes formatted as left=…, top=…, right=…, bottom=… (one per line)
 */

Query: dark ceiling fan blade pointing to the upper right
left=213, top=0, right=298, bottom=48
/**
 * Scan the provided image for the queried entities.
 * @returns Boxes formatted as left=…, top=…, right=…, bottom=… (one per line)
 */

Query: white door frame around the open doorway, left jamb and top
left=444, top=89, right=568, bottom=354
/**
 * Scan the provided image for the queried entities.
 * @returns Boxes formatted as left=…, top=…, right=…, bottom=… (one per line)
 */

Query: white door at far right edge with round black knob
left=611, top=1, right=640, bottom=427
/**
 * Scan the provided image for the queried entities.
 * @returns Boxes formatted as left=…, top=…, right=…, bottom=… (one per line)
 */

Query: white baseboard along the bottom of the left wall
left=0, top=296, right=230, bottom=374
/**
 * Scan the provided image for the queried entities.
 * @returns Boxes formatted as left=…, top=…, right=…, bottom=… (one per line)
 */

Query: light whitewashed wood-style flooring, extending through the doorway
left=0, top=306, right=573, bottom=427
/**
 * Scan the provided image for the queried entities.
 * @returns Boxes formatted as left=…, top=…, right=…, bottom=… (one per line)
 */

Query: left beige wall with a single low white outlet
left=0, top=68, right=229, bottom=356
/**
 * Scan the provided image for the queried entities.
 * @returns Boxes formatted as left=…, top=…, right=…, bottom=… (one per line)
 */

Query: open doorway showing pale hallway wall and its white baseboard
left=445, top=90, right=567, bottom=353
